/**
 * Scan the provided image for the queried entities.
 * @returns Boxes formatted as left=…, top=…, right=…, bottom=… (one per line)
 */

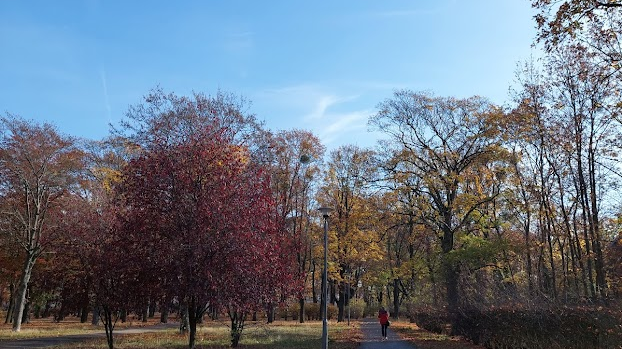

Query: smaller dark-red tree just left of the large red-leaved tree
left=57, top=191, right=133, bottom=349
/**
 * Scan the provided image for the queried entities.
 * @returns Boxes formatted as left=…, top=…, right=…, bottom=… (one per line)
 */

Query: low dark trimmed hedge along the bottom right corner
left=455, top=306, right=622, bottom=349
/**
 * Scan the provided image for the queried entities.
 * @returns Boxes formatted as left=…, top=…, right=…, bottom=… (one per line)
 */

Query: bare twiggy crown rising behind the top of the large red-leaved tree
left=112, top=87, right=270, bottom=158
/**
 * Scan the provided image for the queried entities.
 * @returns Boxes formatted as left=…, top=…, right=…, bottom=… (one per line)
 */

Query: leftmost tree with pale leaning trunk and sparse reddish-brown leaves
left=0, top=115, right=83, bottom=331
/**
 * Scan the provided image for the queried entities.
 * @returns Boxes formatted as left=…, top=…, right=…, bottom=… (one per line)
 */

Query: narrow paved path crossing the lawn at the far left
left=0, top=323, right=179, bottom=349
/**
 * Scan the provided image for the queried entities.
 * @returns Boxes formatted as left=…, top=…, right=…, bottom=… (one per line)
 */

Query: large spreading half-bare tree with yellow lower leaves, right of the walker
left=370, top=90, right=505, bottom=330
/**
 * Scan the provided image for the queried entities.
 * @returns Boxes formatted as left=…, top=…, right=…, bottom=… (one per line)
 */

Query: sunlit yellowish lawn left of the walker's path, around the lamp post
left=0, top=318, right=362, bottom=349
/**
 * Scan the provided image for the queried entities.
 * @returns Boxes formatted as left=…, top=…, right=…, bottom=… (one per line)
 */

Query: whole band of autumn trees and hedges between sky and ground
left=0, top=0, right=622, bottom=348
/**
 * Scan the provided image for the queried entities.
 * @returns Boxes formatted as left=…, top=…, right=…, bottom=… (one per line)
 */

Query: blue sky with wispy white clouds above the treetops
left=0, top=0, right=535, bottom=149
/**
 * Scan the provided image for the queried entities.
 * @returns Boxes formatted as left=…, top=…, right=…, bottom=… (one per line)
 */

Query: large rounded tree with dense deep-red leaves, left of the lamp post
left=119, top=123, right=300, bottom=348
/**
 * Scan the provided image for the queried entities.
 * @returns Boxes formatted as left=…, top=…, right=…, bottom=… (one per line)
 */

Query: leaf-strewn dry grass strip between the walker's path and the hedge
left=391, top=321, right=484, bottom=349
